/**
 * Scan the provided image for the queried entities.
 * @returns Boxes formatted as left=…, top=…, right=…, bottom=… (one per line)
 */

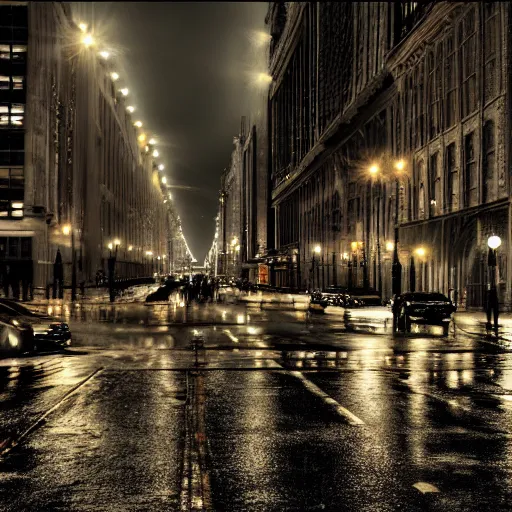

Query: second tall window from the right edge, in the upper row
left=459, top=8, right=477, bottom=117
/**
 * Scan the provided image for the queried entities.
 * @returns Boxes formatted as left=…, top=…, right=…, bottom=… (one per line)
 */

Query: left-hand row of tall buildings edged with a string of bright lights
left=0, top=2, right=181, bottom=295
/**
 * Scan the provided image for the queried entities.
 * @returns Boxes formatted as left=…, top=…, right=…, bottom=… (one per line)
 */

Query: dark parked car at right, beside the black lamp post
left=392, top=292, right=457, bottom=336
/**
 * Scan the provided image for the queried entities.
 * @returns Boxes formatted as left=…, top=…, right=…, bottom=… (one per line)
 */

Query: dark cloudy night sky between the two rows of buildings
left=80, top=2, right=268, bottom=264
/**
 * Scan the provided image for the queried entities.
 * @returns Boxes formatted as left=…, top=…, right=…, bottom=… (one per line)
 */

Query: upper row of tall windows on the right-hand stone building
left=395, top=2, right=499, bottom=154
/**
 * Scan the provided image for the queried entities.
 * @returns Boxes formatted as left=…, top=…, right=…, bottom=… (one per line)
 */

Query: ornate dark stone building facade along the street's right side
left=267, top=2, right=512, bottom=307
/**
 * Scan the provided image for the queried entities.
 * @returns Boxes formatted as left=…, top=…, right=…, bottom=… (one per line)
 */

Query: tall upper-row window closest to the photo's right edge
left=483, top=2, right=499, bottom=103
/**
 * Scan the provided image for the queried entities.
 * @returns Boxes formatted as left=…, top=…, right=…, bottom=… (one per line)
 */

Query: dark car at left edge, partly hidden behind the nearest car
left=0, top=299, right=71, bottom=349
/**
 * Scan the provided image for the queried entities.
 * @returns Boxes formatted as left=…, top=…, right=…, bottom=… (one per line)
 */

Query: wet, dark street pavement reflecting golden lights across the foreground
left=0, top=302, right=512, bottom=512
